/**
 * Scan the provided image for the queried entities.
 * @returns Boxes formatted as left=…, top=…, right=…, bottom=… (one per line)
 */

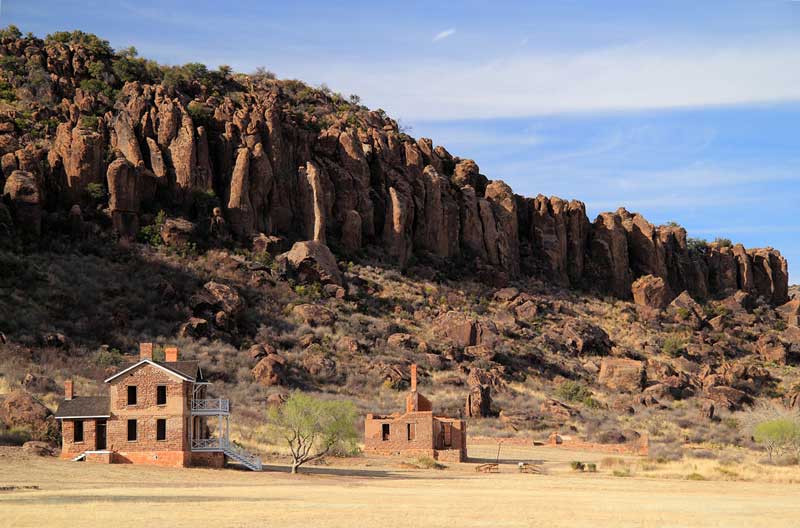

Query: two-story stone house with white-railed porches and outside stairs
left=56, top=343, right=261, bottom=470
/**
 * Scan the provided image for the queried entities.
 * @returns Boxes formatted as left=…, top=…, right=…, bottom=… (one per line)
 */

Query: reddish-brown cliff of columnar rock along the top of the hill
left=0, top=31, right=788, bottom=304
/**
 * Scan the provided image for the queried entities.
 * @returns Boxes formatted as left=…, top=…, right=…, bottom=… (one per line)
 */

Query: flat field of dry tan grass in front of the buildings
left=0, top=445, right=800, bottom=528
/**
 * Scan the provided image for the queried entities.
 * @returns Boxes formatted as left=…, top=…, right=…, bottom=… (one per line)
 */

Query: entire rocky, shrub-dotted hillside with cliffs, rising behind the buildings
left=0, top=28, right=800, bottom=456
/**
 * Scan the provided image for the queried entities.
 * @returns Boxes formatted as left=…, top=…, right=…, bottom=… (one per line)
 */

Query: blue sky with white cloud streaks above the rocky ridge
left=0, top=0, right=800, bottom=282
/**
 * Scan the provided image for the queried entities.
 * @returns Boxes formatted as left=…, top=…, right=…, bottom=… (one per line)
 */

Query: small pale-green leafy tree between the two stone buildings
left=268, top=391, right=358, bottom=473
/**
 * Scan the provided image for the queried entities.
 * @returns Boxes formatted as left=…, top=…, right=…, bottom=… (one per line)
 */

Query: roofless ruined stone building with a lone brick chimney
left=364, top=365, right=467, bottom=462
